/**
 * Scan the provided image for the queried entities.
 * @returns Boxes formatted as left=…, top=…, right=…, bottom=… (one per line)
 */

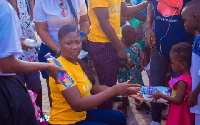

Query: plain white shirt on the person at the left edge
left=0, top=0, right=22, bottom=76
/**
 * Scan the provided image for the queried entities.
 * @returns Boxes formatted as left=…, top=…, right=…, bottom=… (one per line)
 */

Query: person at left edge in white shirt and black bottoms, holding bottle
left=0, top=0, right=65, bottom=125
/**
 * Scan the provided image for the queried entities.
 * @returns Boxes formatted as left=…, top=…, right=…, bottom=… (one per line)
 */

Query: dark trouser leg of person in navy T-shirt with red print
left=150, top=50, right=169, bottom=123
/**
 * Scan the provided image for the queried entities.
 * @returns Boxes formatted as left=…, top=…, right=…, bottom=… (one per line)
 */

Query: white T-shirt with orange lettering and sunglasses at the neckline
left=33, top=0, right=87, bottom=46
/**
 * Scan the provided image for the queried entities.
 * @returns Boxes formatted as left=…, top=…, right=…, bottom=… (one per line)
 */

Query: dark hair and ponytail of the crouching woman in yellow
left=58, top=24, right=95, bottom=85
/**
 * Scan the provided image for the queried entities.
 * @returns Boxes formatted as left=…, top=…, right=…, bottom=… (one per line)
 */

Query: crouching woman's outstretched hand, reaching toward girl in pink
left=112, top=82, right=140, bottom=95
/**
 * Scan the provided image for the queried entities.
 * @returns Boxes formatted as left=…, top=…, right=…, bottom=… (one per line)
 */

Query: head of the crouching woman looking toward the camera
left=58, top=25, right=82, bottom=59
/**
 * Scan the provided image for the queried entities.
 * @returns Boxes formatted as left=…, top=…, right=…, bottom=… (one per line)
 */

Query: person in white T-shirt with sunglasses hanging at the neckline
left=33, top=0, right=90, bottom=105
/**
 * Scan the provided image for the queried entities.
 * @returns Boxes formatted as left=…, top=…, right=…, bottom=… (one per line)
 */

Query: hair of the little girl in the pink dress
left=170, top=42, right=192, bottom=67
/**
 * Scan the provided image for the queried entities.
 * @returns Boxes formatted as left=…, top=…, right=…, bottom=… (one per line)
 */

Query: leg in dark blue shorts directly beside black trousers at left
left=25, top=71, right=43, bottom=115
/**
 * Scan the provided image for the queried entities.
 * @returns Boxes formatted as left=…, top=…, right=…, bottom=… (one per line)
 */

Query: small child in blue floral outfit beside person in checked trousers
left=118, top=25, right=150, bottom=116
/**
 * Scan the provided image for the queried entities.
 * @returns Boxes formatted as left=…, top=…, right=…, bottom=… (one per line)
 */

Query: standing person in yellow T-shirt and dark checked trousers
left=87, top=0, right=148, bottom=109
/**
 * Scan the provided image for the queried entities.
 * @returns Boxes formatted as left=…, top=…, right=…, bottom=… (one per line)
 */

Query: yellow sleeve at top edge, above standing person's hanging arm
left=90, top=0, right=108, bottom=8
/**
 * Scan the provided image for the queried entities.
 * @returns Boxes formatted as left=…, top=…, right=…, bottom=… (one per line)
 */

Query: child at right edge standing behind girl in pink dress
left=181, top=0, right=200, bottom=125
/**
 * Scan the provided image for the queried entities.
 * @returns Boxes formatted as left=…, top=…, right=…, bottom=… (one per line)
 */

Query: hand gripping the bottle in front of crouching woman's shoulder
left=46, top=63, right=66, bottom=84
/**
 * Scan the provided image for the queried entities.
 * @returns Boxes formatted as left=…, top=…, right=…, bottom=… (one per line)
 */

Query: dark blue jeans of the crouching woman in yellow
left=75, top=109, right=126, bottom=125
